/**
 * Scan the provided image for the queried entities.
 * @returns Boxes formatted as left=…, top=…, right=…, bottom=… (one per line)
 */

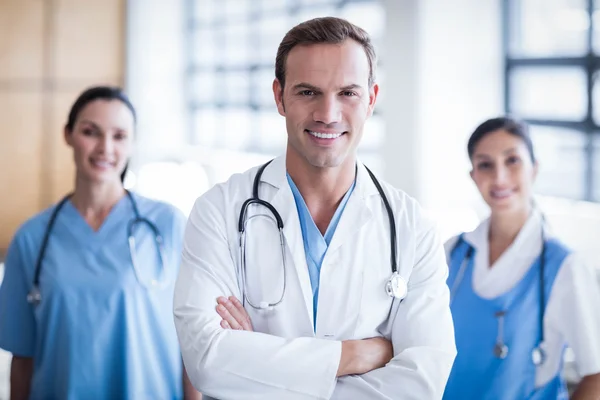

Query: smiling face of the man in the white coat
left=273, top=39, right=378, bottom=172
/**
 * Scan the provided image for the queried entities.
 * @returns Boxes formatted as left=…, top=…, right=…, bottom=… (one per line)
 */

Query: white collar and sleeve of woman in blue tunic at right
left=445, top=209, right=600, bottom=387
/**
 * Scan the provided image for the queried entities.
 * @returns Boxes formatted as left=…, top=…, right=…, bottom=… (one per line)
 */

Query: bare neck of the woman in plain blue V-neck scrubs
left=71, top=177, right=125, bottom=219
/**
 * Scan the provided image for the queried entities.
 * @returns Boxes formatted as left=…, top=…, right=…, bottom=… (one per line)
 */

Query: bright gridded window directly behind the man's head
left=185, top=0, right=385, bottom=164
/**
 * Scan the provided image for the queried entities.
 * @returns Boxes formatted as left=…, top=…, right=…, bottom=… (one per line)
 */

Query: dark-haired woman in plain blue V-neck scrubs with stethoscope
left=0, top=87, right=200, bottom=400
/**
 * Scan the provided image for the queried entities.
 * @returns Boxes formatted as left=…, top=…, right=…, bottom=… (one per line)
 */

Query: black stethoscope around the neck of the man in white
left=238, top=160, right=408, bottom=310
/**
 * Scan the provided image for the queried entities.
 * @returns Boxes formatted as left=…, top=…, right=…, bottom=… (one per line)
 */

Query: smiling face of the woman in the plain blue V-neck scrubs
left=65, top=99, right=134, bottom=183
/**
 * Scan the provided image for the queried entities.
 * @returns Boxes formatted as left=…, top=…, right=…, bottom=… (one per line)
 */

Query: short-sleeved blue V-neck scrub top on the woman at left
left=0, top=194, right=185, bottom=400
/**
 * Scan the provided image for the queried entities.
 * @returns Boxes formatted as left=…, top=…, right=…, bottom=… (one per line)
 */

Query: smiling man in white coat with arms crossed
left=174, top=17, right=456, bottom=400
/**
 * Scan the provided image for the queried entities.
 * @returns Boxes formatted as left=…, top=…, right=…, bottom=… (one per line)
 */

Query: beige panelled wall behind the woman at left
left=0, top=0, right=126, bottom=251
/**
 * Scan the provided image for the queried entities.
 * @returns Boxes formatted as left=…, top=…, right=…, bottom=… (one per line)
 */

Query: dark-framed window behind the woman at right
left=503, top=0, right=600, bottom=202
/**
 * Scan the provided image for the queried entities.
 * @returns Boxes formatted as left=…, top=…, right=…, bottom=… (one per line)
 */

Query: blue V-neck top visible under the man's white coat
left=287, top=174, right=356, bottom=329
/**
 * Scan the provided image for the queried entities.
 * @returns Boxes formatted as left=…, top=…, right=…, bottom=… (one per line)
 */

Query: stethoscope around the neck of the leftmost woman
left=27, top=190, right=167, bottom=305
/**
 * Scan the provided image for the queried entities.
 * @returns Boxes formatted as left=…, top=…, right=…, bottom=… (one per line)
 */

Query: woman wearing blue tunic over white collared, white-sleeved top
left=444, top=118, right=600, bottom=400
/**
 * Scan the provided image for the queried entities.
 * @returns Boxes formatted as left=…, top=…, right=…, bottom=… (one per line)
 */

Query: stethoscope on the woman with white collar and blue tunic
left=450, top=225, right=546, bottom=366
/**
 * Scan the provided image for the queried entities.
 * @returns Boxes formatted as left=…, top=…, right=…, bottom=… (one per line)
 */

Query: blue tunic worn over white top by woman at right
left=443, top=237, right=569, bottom=400
